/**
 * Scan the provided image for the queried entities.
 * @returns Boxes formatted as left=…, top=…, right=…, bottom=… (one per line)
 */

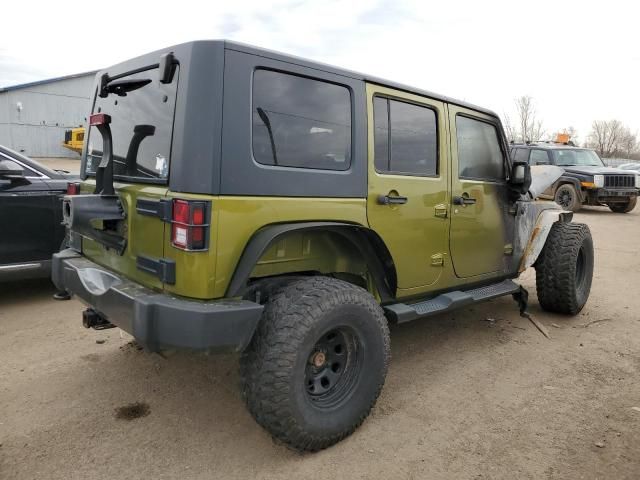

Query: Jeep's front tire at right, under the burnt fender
left=535, top=222, right=593, bottom=315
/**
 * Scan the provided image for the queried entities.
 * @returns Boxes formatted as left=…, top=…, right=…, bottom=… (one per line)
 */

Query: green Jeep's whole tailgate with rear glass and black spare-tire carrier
left=76, top=54, right=180, bottom=289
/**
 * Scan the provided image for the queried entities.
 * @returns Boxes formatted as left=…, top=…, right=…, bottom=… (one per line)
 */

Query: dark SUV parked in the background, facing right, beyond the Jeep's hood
left=511, top=143, right=640, bottom=213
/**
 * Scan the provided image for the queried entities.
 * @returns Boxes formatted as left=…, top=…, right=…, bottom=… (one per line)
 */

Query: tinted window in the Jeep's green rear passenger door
left=373, top=97, right=438, bottom=176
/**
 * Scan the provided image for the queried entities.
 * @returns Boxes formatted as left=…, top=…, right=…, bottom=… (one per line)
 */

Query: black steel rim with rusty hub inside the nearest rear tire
left=304, top=327, right=363, bottom=409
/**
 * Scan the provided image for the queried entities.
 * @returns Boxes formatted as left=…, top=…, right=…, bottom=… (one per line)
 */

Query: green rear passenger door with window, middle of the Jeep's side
left=367, top=85, right=449, bottom=290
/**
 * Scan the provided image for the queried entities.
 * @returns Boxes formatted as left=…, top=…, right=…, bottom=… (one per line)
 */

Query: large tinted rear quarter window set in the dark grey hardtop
left=252, top=70, right=351, bottom=170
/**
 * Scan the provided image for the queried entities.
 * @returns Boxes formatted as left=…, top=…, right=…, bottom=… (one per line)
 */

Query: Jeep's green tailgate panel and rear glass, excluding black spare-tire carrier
left=82, top=66, right=179, bottom=289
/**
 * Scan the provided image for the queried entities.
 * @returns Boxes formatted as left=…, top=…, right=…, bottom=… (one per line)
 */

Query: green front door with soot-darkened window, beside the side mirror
left=449, top=105, right=514, bottom=278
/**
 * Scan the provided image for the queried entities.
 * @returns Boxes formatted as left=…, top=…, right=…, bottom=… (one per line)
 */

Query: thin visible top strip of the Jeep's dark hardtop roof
left=98, top=40, right=499, bottom=119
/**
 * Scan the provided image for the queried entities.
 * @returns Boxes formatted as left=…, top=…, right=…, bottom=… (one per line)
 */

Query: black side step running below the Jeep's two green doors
left=384, top=280, right=520, bottom=323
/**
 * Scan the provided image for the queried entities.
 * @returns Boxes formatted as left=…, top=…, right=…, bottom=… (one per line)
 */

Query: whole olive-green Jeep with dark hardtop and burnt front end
left=52, top=41, right=593, bottom=451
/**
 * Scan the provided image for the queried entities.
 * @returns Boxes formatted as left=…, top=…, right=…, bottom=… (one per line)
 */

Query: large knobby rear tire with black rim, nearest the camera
left=241, top=277, right=389, bottom=451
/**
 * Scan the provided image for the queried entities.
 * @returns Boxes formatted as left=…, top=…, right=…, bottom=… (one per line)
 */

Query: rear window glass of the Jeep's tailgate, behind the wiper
left=85, top=66, right=179, bottom=183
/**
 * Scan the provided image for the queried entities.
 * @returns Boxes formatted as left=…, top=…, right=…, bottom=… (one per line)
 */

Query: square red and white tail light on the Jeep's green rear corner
left=171, top=199, right=209, bottom=250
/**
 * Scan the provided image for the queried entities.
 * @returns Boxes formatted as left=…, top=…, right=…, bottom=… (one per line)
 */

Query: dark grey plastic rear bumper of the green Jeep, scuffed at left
left=52, top=249, right=263, bottom=352
